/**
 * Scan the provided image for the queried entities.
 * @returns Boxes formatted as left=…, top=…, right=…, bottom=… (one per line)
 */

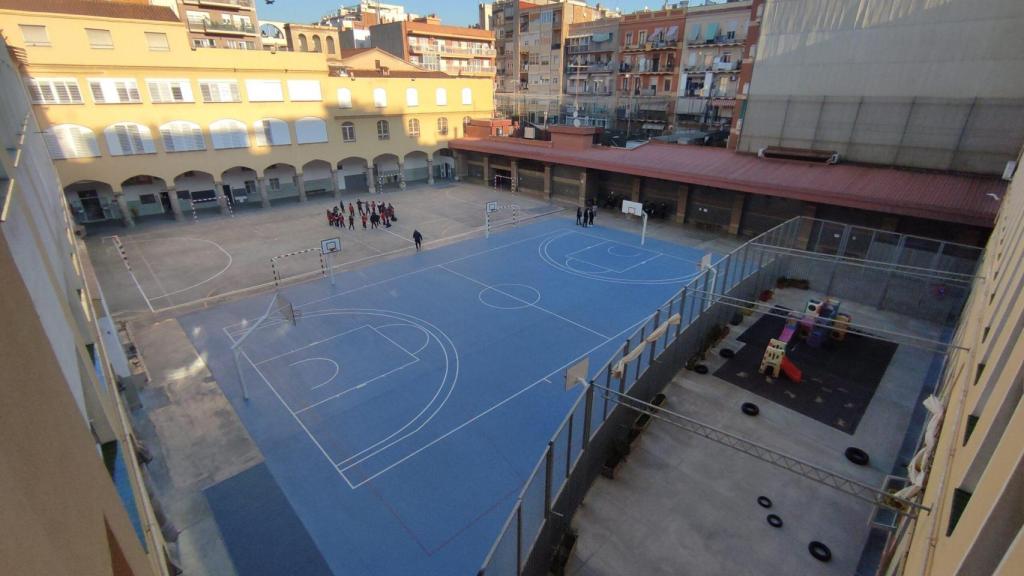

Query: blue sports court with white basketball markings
left=180, top=219, right=703, bottom=576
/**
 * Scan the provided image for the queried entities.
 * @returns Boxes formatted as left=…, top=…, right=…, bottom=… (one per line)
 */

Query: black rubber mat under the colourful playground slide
left=715, top=306, right=897, bottom=435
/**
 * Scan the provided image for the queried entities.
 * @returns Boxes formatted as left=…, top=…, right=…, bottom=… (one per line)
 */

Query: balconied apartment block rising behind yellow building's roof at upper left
left=178, top=0, right=261, bottom=50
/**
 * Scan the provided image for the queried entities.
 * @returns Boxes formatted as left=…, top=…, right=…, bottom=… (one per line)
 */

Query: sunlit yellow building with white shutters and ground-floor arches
left=0, top=0, right=493, bottom=224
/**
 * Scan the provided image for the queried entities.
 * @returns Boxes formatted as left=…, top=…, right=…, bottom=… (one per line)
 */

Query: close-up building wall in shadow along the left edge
left=0, top=33, right=169, bottom=576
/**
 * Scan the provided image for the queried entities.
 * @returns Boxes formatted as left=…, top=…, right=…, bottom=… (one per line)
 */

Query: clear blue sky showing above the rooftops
left=255, top=0, right=720, bottom=26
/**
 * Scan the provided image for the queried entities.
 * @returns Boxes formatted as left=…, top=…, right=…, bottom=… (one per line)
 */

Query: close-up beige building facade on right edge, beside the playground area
left=879, top=151, right=1024, bottom=576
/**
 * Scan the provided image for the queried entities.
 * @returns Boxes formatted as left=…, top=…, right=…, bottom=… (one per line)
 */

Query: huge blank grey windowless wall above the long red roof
left=737, top=0, right=1024, bottom=174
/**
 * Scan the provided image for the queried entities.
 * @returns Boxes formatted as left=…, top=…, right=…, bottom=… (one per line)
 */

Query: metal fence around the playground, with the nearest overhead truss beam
left=477, top=216, right=981, bottom=576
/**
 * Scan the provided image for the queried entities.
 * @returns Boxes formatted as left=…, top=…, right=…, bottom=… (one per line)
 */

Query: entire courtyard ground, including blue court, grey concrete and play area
left=87, top=182, right=970, bottom=576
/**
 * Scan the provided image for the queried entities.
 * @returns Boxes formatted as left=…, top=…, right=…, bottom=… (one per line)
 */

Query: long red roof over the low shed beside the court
left=449, top=137, right=1007, bottom=228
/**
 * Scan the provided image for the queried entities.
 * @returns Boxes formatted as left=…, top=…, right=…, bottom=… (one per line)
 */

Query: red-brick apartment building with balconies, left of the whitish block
left=615, top=7, right=687, bottom=136
